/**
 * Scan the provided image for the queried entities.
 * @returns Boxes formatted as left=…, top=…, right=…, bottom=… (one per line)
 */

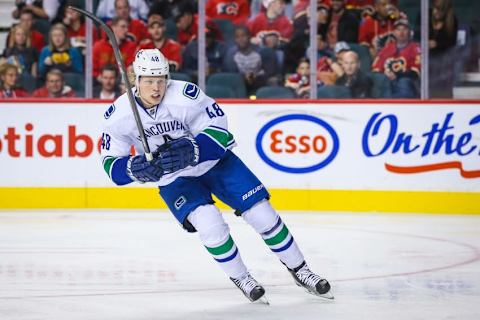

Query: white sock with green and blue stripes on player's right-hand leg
left=242, top=200, right=305, bottom=269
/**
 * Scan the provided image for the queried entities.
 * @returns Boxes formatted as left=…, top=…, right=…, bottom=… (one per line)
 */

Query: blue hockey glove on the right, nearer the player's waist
left=158, top=137, right=200, bottom=173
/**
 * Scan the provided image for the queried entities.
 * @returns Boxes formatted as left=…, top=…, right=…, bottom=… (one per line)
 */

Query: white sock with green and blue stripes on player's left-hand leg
left=188, top=205, right=247, bottom=279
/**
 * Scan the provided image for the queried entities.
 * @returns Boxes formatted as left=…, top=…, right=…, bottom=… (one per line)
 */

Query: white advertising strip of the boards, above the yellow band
left=0, top=102, right=480, bottom=192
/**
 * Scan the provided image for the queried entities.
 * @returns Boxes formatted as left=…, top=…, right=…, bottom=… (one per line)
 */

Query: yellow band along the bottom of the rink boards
left=0, top=187, right=480, bottom=214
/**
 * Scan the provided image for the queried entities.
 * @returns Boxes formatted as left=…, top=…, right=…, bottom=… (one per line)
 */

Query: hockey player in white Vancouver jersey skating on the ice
left=102, top=49, right=333, bottom=301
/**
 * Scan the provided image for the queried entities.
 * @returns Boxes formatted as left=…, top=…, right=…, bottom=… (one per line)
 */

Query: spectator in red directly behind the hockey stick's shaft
left=93, top=17, right=137, bottom=78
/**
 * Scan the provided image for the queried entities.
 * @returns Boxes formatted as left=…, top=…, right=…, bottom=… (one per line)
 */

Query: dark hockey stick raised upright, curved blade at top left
left=68, top=6, right=153, bottom=161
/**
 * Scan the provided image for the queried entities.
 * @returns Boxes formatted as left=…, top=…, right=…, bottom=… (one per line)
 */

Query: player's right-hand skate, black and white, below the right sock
left=288, top=261, right=333, bottom=299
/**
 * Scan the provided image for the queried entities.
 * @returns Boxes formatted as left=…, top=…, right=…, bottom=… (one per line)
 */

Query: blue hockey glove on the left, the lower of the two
left=127, top=155, right=163, bottom=183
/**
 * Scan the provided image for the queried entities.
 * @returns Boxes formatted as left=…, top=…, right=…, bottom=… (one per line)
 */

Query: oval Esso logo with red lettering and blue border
left=256, top=114, right=339, bottom=173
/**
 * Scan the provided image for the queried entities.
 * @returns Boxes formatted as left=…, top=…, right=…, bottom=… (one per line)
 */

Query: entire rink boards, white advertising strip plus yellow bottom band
left=0, top=101, right=480, bottom=214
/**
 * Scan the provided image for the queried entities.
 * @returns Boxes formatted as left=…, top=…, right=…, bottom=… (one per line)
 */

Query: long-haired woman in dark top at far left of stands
left=3, top=24, right=38, bottom=76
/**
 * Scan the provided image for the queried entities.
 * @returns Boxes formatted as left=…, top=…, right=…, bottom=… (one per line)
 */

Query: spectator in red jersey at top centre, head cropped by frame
left=205, top=0, right=250, bottom=25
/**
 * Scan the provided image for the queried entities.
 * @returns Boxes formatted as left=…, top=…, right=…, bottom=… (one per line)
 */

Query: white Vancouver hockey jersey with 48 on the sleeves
left=101, top=80, right=235, bottom=186
